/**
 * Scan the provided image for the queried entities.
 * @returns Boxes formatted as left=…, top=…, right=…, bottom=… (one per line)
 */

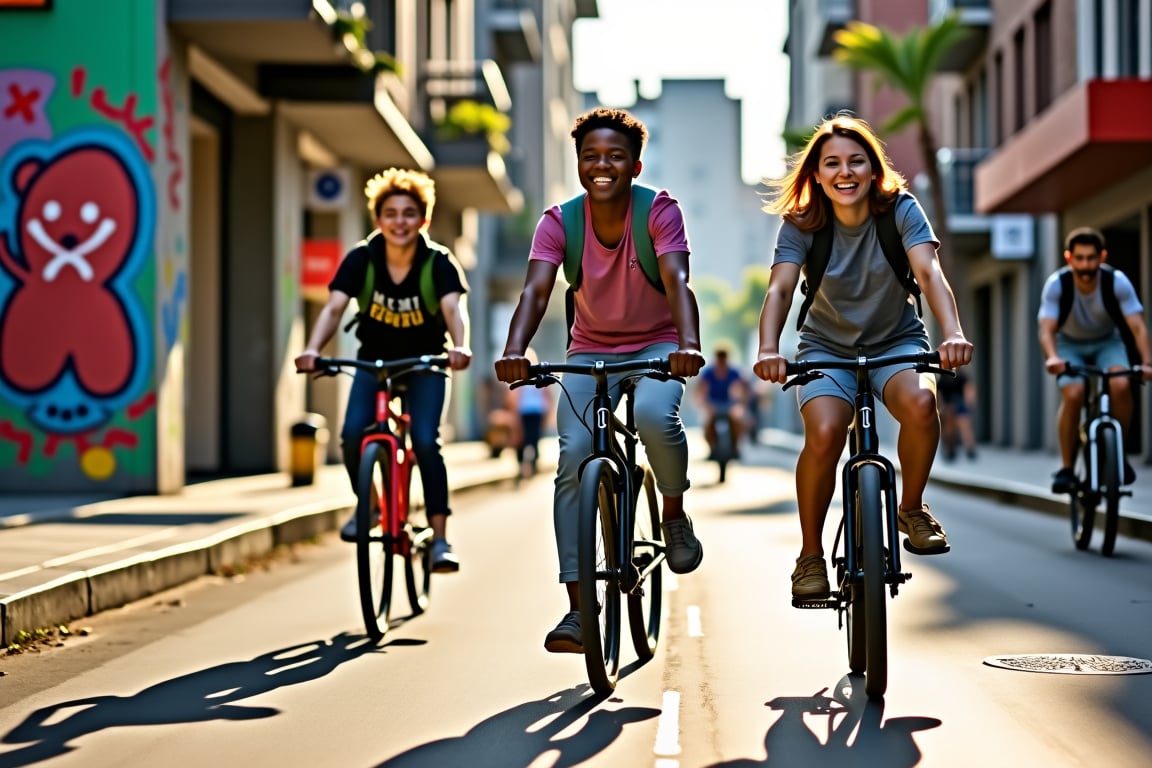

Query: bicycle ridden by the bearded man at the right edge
left=1063, top=363, right=1143, bottom=557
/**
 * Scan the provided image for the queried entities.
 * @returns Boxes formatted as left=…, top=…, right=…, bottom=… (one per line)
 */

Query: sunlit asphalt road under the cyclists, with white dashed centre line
left=0, top=451, right=1152, bottom=768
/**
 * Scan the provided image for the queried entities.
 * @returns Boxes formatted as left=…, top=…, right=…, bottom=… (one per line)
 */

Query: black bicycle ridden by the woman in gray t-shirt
left=782, top=352, right=955, bottom=700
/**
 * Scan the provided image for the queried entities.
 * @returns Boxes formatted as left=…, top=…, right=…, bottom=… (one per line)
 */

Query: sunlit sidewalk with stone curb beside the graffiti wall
left=0, top=441, right=529, bottom=647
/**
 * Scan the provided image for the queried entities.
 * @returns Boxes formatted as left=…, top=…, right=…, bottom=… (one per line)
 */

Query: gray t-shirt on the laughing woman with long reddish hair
left=772, top=195, right=940, bottom=357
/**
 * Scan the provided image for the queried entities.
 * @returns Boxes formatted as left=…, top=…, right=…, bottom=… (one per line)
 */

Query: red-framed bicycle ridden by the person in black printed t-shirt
left=306, top=355, right=448, bottom=640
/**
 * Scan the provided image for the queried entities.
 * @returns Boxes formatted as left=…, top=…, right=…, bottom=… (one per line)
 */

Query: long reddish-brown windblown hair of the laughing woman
left=763, top=109, right=907, bottom=231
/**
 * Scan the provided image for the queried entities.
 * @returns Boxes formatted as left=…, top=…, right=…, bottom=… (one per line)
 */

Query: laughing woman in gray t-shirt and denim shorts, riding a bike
left=753, top=113, right=972, bottom=599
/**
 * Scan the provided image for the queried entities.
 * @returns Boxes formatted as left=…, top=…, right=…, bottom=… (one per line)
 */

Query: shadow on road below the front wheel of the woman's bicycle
left=710, top=675, right=941, bottom=768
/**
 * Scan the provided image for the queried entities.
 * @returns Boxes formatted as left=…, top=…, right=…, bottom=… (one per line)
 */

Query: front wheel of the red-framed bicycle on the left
left=356, top=442, right=395, bottom=640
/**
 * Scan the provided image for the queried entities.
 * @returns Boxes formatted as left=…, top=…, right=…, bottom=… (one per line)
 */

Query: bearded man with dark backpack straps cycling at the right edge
left=1037, top=227, right=1152, bottom=493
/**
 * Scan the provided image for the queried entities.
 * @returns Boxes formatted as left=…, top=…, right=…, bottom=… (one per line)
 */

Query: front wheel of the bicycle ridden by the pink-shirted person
left=577, top=459, right=620, bottom=694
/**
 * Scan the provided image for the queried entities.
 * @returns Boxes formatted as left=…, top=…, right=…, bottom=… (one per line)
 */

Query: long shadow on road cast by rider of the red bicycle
left=0, top=632, right=387, bottom=768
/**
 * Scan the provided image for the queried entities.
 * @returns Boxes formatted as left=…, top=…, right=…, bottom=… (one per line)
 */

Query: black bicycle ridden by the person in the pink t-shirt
left=511, top=358, right=673, bottom=694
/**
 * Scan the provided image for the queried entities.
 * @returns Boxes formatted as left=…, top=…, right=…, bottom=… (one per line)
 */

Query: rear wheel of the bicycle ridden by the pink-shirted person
left=628, top=466, right=664, bottom=662
